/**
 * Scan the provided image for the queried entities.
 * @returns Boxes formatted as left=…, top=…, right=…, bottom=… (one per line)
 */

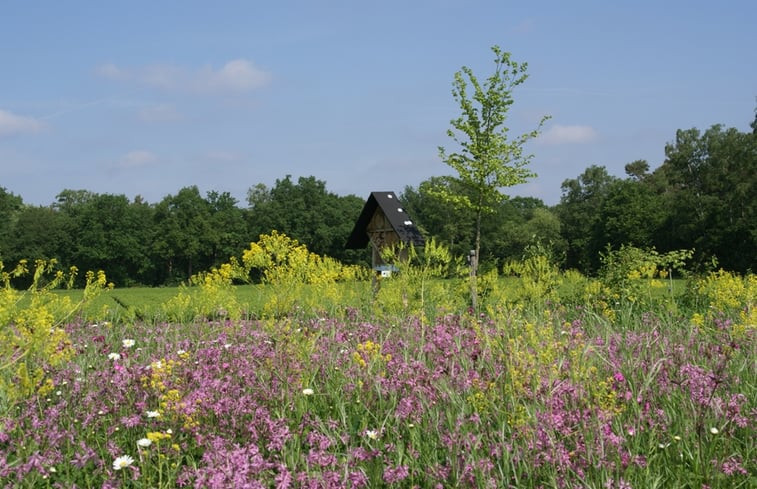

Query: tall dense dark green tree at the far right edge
left=656, top=125, right=757, bottom=272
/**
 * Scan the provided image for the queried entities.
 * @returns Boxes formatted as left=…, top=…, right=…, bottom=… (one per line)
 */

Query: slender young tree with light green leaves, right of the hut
left=437, top=46, right=548, bottom=308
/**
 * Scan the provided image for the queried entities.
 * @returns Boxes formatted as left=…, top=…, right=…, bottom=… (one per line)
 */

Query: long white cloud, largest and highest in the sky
left=95, top=59, right=271, bottom=93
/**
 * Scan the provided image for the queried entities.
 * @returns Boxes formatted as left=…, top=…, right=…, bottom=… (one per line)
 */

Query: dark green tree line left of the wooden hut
left=0, top=176, right=364, bottom=286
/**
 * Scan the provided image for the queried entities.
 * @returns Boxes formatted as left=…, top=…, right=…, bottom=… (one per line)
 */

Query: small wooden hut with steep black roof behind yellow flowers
left=345, top=192, right=425, bottom=273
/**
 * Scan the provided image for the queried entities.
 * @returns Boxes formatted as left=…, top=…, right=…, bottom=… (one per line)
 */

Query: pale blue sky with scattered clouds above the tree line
left=0, top=0, right=757, bottom=205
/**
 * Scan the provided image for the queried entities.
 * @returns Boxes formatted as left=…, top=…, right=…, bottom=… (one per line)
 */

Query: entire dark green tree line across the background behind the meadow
left=0, top=118, right=757, bottom=286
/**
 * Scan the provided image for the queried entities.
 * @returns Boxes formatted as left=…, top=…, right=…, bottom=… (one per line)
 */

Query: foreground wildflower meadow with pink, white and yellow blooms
left=0, top=238, right=757, bottom=489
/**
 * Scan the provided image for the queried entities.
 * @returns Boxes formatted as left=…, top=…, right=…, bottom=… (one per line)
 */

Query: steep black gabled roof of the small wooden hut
left=345, top=192, right=426, bottom=249
